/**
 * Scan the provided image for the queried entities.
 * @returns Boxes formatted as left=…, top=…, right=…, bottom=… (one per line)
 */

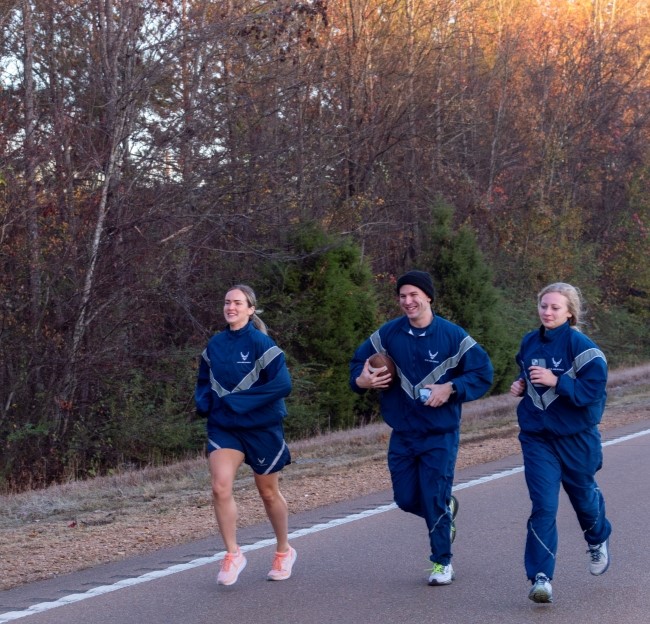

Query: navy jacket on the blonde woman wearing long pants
left=517, top=321, right=607, bottom=436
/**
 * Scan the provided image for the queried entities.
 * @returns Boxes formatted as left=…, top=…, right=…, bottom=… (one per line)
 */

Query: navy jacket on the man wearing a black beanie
left=350, top=315, right=493, bottom=433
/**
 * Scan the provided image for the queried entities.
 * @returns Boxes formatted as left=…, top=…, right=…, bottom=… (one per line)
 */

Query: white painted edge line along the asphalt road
left=0, top=429, right=650, bottom=624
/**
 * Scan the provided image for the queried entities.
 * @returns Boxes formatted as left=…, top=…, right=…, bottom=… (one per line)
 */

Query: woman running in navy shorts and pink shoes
left=195, top=284, right=296, bottom=585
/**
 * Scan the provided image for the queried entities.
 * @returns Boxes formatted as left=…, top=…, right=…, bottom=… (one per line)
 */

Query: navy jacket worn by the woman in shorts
left=195, top=322, right=291, bottom=429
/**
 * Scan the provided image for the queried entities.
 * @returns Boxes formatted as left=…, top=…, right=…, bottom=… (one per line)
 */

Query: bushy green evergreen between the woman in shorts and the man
left=264, top=224, right=377, bottom=436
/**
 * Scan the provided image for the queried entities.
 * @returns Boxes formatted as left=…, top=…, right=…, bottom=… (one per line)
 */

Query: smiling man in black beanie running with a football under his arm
left=350, top=271, right=493, bottom=585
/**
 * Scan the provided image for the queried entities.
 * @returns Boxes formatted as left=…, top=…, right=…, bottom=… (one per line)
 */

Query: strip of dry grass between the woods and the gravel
left=0, top=364, right=650, bottom=528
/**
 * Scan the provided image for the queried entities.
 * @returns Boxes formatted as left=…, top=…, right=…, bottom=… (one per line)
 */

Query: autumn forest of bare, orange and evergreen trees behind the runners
left=0, top=0, right=650, bottom=491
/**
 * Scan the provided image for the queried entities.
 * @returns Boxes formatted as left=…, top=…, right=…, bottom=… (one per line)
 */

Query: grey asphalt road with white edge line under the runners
left=0, top=421, right=650, bottom=624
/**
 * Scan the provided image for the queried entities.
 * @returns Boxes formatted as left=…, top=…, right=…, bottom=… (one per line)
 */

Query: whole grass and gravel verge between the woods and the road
left=0, top=365, right=650, bottom=590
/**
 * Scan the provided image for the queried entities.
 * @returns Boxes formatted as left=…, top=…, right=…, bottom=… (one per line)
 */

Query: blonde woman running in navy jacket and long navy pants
left=510, top=283, right=612, bottom=602
